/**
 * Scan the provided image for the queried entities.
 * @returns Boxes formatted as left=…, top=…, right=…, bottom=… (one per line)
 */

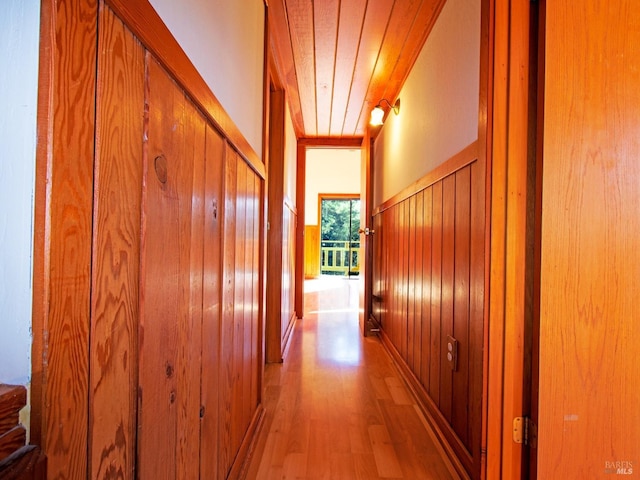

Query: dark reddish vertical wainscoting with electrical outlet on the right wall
left=372, top=143, right=485, bottom=478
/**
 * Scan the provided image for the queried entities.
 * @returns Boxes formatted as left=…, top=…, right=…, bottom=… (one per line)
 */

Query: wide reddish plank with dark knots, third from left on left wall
left=138, top=54, right=205, bottom=478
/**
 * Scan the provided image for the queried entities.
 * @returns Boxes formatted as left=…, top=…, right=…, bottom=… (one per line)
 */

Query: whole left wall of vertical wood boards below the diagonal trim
left=32, top=0, right=264, bottom=479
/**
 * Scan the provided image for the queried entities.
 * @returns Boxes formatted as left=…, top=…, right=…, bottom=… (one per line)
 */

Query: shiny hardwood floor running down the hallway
left=246, top=278, right=457, bottom=480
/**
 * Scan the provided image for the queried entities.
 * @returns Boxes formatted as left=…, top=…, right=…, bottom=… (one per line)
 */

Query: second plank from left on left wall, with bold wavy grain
left=89, top=8, right=145, bottom=478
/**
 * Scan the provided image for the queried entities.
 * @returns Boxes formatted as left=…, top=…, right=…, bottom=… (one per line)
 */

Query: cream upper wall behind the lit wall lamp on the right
left=373, top=0, right=480, bottom=206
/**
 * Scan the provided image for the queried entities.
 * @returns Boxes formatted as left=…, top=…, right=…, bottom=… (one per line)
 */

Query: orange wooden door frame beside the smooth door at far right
left=480, top=0, right=542, bottom=479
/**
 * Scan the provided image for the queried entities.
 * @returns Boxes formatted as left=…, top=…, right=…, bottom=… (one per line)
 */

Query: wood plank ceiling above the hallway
left=268, top=0, right=446, bottom=138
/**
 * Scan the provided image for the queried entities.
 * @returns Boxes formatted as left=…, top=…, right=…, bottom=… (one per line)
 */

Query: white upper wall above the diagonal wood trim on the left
left=149, top=0, right=264, bottom=157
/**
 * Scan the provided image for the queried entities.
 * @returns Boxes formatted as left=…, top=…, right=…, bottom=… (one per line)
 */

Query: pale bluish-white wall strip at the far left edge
left=0, top=0, right=40, bottom=385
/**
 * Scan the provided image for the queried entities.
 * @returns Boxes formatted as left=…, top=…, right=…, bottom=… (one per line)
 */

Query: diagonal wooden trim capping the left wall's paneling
left=105, top=0, right=266, bottom=179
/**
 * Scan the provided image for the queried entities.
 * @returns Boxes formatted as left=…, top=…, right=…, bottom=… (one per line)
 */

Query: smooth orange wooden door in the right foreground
left=538, top=1, right=640, bottom=478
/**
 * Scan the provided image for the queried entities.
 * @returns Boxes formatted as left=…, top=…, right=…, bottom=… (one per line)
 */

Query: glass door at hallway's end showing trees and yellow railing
left=320, top=196, right=360, bottom=278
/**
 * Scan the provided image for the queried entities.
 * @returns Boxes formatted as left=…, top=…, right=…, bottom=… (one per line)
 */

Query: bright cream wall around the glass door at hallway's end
left=304, top=148, right=361, bottom=225
